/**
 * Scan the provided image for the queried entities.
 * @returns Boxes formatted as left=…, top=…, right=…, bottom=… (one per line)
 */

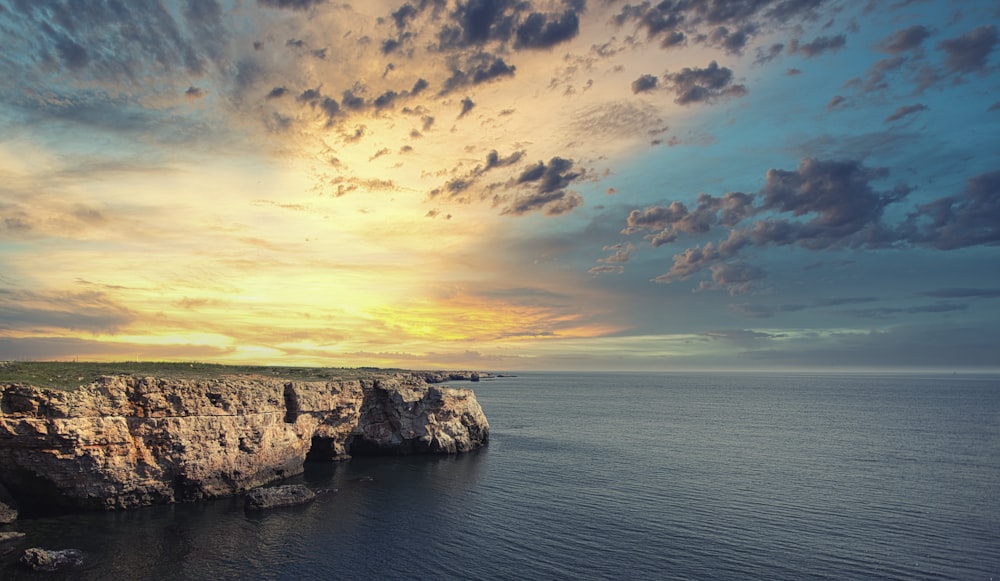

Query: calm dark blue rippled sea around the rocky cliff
left=0, top=373, right=1000, bottom=580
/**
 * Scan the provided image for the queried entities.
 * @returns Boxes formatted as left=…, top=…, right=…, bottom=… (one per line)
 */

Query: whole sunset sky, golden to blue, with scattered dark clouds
left=0, top=0, right=1000, bottom=372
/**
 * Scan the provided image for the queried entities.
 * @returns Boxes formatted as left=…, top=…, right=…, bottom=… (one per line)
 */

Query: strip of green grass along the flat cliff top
left=0, top=361, right=408, bottom=389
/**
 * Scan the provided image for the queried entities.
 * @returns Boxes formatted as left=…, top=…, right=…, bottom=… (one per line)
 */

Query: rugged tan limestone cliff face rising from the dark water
left=0, top=374, right=489, bottom=512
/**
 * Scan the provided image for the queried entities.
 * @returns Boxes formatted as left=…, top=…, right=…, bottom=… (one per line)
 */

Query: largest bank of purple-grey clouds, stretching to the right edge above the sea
left=622, top=159, right=1000, bottom=286
